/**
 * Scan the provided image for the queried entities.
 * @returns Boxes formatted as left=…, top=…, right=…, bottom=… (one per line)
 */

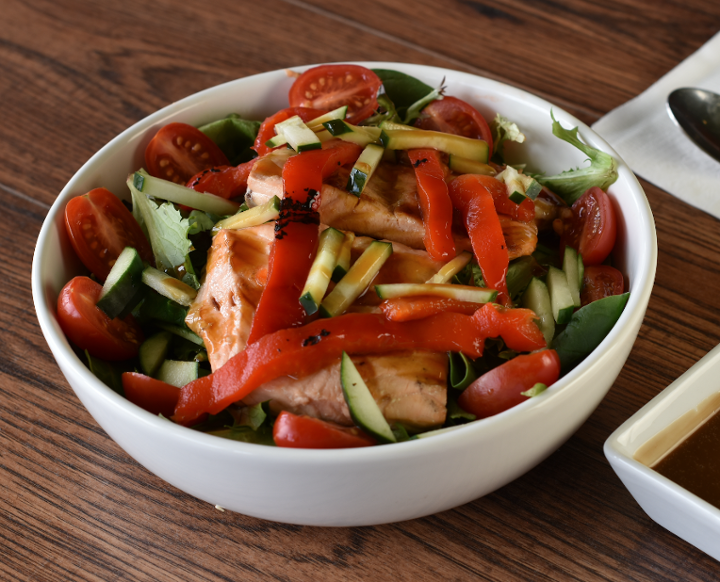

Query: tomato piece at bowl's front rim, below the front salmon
left=273, top=411, right=376, bottom=449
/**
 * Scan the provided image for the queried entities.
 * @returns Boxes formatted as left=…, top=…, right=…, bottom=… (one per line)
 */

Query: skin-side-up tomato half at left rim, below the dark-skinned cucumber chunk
left=57, top=277, right=144, bottom=362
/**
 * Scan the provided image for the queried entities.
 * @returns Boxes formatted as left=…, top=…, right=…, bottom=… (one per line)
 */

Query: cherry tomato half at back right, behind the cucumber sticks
left=415, top=97, right=493, bottom=155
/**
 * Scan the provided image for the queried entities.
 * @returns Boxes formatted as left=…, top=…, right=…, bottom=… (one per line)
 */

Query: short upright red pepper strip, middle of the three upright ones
left=408, top=149, right=455, bottom=261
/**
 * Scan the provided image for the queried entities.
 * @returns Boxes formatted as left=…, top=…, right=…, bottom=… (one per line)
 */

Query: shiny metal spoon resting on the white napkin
left=668, top=88, right=720, bottom=162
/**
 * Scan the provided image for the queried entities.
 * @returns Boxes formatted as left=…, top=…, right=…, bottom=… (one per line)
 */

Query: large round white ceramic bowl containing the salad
left=32, top=63, right=657, bottom=526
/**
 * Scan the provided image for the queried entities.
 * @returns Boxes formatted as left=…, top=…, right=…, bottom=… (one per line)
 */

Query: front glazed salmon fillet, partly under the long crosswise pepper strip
left=186, top=223, right=447, bottom=430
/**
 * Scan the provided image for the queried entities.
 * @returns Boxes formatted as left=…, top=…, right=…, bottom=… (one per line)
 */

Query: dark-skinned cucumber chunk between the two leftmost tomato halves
left=97, top=247, right=145, bottom=319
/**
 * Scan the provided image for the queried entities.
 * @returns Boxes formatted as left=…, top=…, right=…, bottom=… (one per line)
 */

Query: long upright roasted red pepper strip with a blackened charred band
left=248, top=140, right=361, bottom=344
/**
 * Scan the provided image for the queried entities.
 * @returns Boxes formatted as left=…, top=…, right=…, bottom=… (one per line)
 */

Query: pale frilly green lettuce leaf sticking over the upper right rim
left=537, top=112, right=618, bottom=204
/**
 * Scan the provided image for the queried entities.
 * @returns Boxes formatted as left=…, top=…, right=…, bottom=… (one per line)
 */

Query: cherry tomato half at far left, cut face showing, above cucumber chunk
left=65, top=188, right=153, bottom=281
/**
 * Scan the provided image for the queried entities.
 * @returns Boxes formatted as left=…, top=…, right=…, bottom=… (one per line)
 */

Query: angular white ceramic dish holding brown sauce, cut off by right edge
left=605, top=346, right=720, bottom=560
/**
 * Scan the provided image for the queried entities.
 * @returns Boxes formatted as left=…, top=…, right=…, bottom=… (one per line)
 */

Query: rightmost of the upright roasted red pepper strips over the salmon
left=449, top=174, right=510, bottom=302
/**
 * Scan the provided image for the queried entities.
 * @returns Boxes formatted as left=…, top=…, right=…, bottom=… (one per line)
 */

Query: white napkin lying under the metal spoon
left=592, top=33, right=720, bottom=218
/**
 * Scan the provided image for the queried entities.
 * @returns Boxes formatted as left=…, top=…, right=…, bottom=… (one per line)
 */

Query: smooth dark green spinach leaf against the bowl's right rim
left=552, top=293, right=630, bottom=373
